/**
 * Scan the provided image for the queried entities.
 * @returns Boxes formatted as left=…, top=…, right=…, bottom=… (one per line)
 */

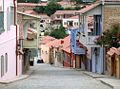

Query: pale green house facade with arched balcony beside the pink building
left=17, top=11, right=40, bottom=73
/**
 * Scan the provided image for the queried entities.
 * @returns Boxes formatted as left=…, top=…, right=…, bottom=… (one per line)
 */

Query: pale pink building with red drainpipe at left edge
left=0, top=0, right=22, bottom=82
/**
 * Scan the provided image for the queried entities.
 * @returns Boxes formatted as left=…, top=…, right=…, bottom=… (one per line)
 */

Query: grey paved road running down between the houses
left=0, top=64, right=111, bottom=89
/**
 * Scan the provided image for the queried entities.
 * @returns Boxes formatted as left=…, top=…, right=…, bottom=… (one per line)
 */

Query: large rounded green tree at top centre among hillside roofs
left=44, top=1, right=63, bottom=16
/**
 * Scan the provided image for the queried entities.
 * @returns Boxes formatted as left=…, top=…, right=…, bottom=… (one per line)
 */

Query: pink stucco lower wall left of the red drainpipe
left=0, top=27, right=16, bottom=80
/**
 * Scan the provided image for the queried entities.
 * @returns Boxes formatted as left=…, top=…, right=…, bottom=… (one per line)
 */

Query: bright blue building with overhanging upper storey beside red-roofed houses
left=69, top=28, right=87, bottom=69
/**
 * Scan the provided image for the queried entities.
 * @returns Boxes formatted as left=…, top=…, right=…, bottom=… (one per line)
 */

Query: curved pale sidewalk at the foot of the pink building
left=0, top=69, right=34, bottom=84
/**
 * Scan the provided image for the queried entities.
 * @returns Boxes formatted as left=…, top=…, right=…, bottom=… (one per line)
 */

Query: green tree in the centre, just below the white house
left=50, top=26, right=67, bottom=39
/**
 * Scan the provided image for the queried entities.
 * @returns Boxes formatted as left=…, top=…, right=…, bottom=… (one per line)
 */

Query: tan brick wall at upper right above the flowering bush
left=103, top=5, right=120, bottom=31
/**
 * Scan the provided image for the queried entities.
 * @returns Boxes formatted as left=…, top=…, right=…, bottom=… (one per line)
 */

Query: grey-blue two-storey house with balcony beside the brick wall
left=77, top=2, right=104, bottom=74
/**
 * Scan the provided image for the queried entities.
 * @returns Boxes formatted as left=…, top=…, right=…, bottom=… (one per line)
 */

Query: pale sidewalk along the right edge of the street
left=84, top=71, right=120, bottom=89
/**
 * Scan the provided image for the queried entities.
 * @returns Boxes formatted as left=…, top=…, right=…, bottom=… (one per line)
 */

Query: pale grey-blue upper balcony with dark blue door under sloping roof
left=80, top=15, right=102, bottom=47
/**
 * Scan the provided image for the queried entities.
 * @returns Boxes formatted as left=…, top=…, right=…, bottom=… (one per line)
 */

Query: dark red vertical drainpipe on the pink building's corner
left=13, top=0, right=18, bottom=76
